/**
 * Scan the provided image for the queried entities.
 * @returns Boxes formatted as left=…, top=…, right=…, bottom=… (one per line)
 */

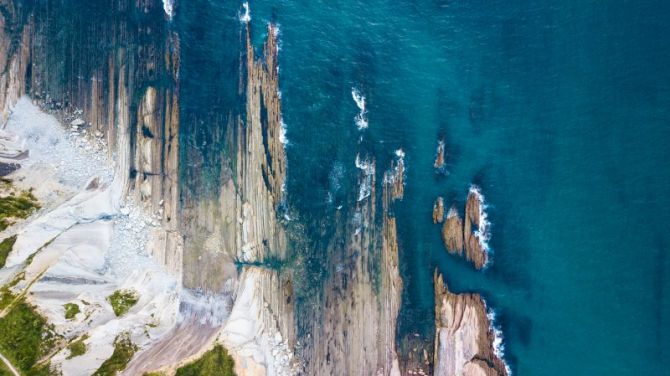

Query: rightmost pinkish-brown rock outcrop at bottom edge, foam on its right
left=433, top=271, right=509, bottom=376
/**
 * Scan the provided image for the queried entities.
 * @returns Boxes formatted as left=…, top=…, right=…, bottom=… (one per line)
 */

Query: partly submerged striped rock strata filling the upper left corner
left=0, top=0, right=182, bottom=275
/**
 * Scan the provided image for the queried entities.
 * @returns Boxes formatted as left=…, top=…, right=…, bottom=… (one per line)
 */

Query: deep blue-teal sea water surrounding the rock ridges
left=172, top=0, right=670, bottom=375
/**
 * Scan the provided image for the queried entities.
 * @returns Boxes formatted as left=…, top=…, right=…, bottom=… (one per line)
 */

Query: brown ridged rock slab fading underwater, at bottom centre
left=304, top=152, right=404, bottom=375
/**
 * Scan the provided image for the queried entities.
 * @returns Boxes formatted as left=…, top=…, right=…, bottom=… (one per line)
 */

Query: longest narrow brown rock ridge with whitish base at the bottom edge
left=219, top=23, right=298, bottom=375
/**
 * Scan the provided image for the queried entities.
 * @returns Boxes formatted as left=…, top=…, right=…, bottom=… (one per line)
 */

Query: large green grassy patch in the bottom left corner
left=0, top=301, right=57, bottom=375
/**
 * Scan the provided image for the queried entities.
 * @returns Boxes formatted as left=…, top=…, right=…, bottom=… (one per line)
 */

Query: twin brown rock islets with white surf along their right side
left=433, top=185, right=489, bottom=269
